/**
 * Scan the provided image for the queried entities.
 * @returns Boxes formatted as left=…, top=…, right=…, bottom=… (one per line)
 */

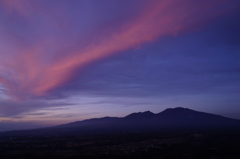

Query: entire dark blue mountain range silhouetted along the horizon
left=0, top=107, right=240, bottom=136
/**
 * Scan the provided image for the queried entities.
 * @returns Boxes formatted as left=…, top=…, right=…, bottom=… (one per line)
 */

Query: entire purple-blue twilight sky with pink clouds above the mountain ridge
left=0, top=0, right=240, bottom=131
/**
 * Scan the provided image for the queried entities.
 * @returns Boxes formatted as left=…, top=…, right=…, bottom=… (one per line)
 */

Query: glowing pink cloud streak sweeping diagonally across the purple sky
left=0, top=0, right=238, bottom=99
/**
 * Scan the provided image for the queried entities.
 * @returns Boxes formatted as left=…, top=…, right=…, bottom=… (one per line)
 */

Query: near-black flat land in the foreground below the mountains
left=0, top=131, right=240, bottom=159
